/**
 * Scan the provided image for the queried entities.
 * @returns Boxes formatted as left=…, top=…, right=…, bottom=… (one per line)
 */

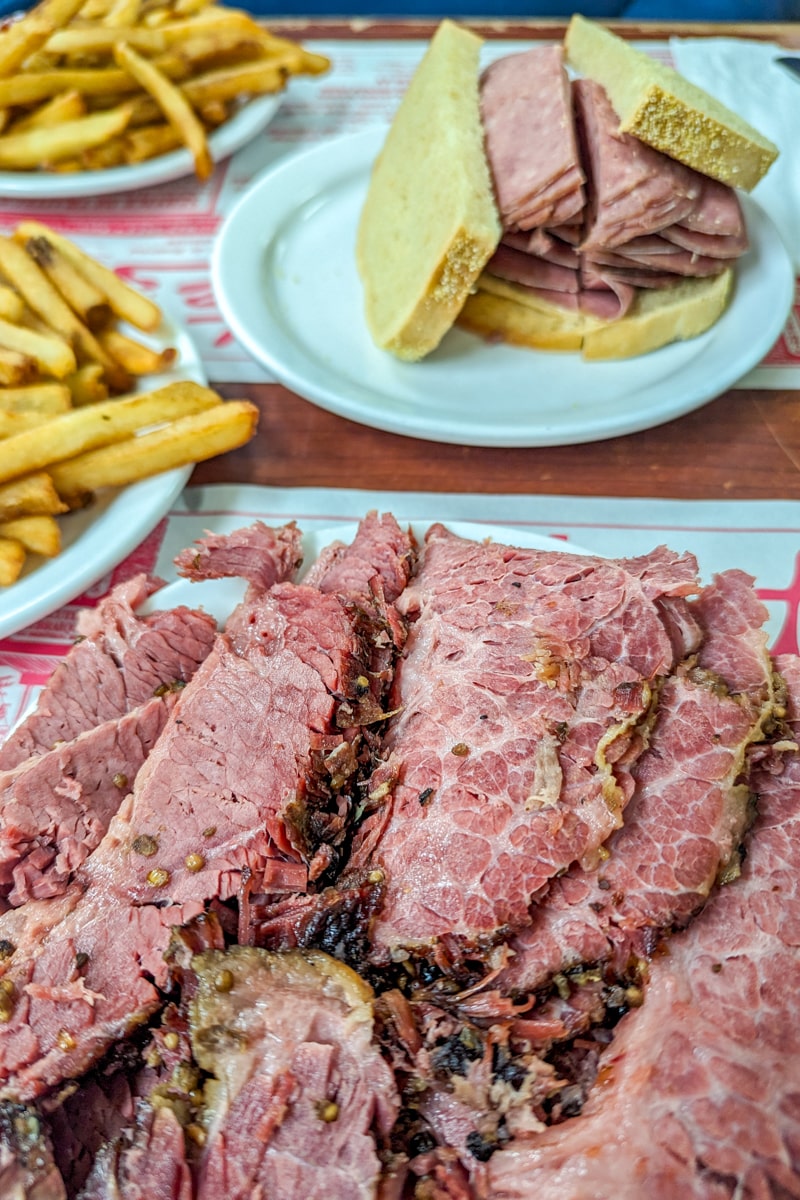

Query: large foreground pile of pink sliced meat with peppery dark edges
left=0, top=518, right=800, bottom=1200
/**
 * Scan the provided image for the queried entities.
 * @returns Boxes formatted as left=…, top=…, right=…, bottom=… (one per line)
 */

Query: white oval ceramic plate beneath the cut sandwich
left=212, top=128, right=794, bottom=446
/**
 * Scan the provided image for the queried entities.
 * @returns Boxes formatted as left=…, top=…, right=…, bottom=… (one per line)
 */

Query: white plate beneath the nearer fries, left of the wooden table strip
left=0, top=318, right=206, bottom=638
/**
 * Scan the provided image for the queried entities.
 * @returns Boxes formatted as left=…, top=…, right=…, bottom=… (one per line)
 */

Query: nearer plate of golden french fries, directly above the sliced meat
left=0, top=221, right=258, bottom=637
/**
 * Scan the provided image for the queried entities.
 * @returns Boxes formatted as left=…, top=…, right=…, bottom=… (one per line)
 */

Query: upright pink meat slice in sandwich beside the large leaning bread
left=481, top=46, right=583, bottom=228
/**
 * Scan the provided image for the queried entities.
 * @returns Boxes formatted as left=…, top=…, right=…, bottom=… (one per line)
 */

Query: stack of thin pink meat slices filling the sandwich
left=481, top=46, right=747, bottom=320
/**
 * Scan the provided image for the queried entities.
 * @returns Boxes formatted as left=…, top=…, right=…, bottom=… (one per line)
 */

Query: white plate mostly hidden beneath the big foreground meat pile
left=137, top=517, right=591, bottom=625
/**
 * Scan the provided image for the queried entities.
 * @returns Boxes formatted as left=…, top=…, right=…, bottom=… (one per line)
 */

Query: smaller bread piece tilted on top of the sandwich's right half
left=565, top=16, right=778, bottom=191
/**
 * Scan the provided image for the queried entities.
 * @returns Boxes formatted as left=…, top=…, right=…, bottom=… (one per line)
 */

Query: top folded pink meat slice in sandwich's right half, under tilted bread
left=573, top=79, right=702, bottom=250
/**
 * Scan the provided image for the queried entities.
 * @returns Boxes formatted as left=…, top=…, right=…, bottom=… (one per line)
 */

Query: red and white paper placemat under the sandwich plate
left=0, top=41, right=800, bottom=388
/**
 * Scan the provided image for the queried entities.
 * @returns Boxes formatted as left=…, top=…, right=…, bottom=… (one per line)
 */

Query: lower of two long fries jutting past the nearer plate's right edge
left=48, top=400, right=258, bottom=499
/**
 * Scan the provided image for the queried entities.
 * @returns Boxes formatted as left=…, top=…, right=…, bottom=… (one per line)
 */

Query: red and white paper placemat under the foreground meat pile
left=0, top=486, right=800, bottom=740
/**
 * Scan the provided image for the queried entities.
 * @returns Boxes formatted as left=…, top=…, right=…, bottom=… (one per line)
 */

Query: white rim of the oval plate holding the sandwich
left=211, top=125, right=795, bottom=448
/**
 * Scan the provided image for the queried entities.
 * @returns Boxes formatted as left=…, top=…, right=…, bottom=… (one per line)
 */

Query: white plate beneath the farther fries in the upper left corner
left=0, top=94, right=282, bottom=200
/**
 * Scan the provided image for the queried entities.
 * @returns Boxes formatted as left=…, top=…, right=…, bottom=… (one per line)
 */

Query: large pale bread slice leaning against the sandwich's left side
left=356, top=20, right=501, bottom=360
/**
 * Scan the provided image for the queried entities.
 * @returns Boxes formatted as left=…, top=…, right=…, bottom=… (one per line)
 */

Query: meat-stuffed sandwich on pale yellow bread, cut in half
left=356, top=16, right=777, bottom=361
